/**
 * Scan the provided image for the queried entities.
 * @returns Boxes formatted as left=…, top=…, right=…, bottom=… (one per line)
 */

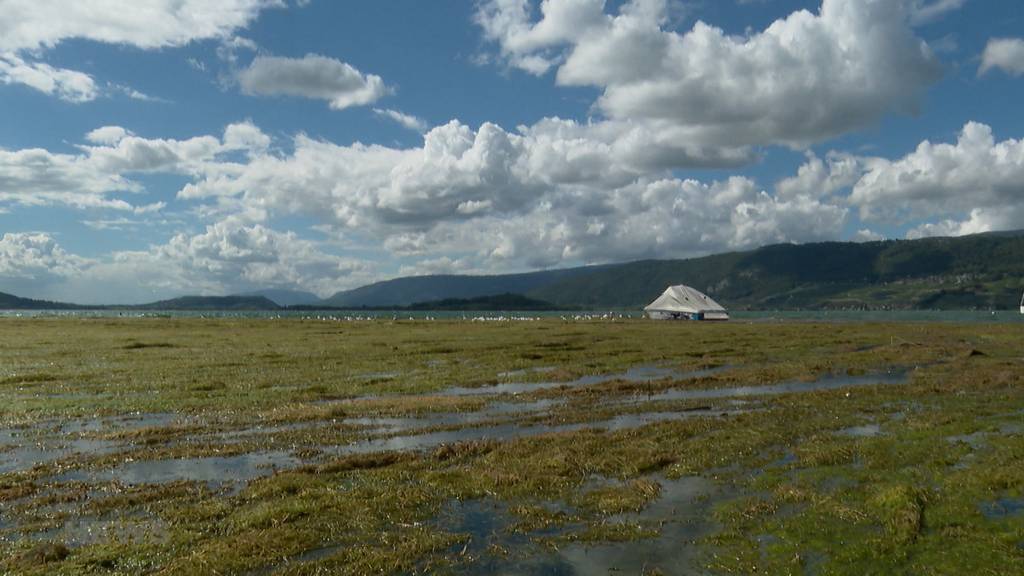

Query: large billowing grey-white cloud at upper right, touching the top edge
left=477, top=0, right=941, bottom=147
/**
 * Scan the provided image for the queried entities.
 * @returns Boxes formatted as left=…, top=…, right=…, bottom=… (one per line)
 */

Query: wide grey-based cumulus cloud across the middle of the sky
left=180, top=119, right=749, bottom=234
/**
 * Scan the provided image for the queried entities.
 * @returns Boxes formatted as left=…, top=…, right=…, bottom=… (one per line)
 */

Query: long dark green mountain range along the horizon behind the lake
left=6, top=232, right=1024, bottom=311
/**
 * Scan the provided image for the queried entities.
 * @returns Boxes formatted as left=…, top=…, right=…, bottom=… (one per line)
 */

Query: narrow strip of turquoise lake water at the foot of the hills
left=0, top=310, right=1024, bottom=324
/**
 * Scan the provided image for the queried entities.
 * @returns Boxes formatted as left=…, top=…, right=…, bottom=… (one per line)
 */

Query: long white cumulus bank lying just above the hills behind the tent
left=406, top=177, right=847, bottom=271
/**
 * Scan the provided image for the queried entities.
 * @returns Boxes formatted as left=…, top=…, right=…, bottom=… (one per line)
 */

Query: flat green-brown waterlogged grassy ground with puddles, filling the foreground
left=0, top=318, right=1024, bottom=575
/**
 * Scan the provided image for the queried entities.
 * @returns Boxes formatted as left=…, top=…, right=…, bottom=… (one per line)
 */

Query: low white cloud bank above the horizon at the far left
left=0, top=217, right=376, bottom=303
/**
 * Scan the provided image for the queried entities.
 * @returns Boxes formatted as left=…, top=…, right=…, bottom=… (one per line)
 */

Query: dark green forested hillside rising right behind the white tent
left=528, top=235, right=1024, bottom=308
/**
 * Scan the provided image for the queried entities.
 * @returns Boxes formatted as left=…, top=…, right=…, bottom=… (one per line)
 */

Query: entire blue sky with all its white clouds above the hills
left=0, top=0, right=1024, bottom=302
